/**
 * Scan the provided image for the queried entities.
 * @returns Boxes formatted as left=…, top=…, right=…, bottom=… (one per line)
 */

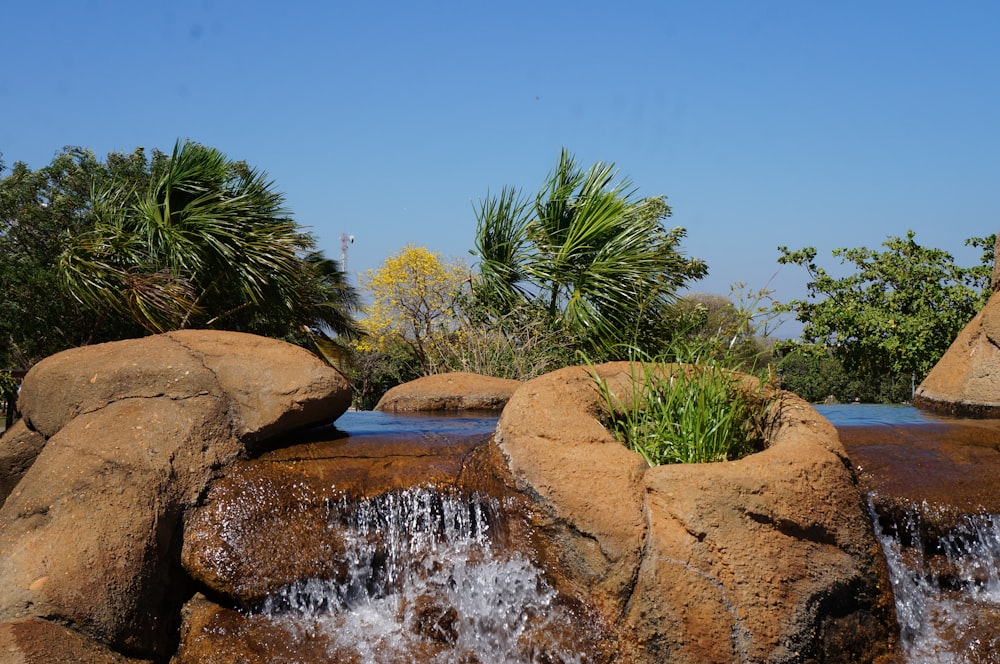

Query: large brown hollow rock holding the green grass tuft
left=496, top=363, right=898, bottom=664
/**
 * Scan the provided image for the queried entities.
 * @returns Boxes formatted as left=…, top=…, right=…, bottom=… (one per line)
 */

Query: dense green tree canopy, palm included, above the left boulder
left=0, top=142, right=357, bottom=367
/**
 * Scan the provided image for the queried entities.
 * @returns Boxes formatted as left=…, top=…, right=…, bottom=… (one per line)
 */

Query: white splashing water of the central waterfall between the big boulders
left=262, top=488, right=585, bottom=664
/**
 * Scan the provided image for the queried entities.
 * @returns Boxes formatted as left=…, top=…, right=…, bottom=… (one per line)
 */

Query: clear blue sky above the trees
left=0, top=0, right=1000, bottom=334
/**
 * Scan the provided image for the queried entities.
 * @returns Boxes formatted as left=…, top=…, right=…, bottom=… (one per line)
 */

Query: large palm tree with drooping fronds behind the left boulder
left=59, top=141, right=358, bottom=344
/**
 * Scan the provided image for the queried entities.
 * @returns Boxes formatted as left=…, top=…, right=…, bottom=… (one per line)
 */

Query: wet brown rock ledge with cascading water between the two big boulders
left=176, top=420, right=613, bottom=664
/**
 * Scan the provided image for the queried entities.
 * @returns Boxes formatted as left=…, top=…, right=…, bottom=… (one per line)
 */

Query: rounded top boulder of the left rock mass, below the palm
left=18, top=330, right=351, bottom=452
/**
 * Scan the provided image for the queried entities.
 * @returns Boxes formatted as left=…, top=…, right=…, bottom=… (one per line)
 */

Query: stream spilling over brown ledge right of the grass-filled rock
left=818, top=405, right=1000, bottom=664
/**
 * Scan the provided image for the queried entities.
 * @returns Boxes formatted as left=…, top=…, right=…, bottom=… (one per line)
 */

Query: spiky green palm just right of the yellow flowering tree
left=472, top=150, right=707, bottom=354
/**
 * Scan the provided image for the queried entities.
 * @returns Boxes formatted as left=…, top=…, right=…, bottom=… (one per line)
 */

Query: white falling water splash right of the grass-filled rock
left=868, top=496, right=1000, bottom=664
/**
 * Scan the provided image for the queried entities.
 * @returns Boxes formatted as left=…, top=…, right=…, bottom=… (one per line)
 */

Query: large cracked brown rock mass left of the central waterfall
left=0, top=331, right=350, bottom=659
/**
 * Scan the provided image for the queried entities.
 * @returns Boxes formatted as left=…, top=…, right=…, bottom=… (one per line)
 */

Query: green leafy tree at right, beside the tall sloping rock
left=778, top=231, right=995, bottom=392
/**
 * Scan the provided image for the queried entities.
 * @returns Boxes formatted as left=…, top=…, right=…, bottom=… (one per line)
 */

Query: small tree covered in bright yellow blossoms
left=355, top=245, right=468, bottom=375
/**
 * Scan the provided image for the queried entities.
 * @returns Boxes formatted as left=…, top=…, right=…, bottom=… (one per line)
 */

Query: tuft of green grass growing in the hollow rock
left=593, top=362, right=771, bottom=466
